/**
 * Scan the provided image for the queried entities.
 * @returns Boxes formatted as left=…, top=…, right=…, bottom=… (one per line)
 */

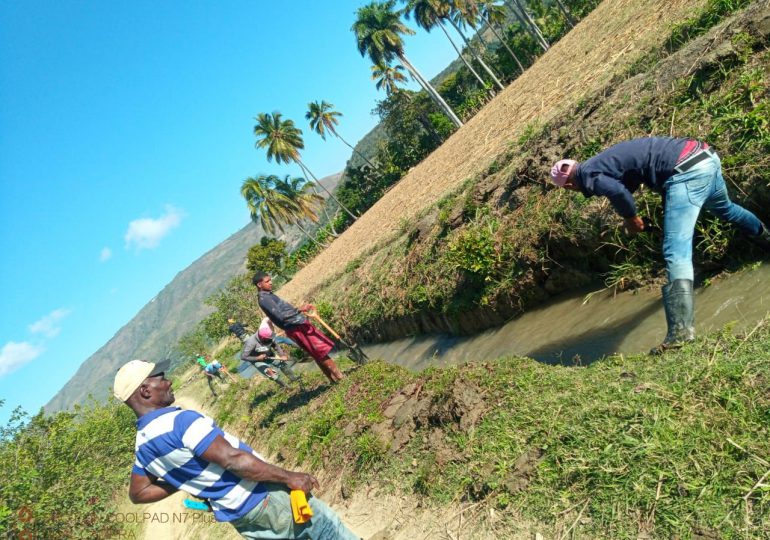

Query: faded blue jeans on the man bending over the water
left=663, top=150, right=762, bottom=283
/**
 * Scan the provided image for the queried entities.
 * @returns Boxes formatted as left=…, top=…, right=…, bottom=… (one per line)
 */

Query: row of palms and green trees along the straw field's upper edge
left=241, top=0, right=599, bottom=284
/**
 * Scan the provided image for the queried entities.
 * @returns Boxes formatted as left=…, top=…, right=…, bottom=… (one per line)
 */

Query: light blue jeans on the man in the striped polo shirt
left=231, top=483, right=360, bottom=540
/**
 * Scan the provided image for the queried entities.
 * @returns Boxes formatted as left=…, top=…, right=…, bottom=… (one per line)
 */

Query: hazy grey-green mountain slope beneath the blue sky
left=44, top=173, right=341, bottom=413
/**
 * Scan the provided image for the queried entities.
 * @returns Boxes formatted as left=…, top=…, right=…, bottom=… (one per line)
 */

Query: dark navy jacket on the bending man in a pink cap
left=575, top=137, right=690, bottom=218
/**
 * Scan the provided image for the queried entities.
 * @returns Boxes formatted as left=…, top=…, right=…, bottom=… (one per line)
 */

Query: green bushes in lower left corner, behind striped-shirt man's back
left=0, top=399, right=136, bottom=539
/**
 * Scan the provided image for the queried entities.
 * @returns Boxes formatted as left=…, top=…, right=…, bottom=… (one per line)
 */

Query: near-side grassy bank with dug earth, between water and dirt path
left=207, top=320, right=770, bottom=538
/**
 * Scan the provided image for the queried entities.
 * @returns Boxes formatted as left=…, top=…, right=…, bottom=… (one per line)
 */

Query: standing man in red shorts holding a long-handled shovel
left=251, top=272, right=344, bottom=383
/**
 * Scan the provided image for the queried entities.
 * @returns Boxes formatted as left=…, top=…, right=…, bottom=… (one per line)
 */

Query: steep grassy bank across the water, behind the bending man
left=300, top=2, right=770, bottom=339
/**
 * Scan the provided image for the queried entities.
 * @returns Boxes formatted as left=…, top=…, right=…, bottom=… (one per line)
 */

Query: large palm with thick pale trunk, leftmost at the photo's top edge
left=351, top=0, right=463, bottom=127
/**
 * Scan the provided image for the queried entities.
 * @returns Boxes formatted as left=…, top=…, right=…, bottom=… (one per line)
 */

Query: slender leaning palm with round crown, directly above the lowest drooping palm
left=254, top=111, right=358, bottom=221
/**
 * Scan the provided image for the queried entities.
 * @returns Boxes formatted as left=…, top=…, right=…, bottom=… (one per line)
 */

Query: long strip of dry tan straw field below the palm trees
left=281, top=0, right=705, bottom=301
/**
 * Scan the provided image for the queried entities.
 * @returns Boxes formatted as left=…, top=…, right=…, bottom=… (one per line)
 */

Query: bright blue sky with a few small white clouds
left=0, top=0, right=453, bottom=423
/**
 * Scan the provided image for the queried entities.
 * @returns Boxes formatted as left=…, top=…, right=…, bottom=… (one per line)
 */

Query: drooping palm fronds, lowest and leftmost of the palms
left=241, top=175, right=326, bottom=247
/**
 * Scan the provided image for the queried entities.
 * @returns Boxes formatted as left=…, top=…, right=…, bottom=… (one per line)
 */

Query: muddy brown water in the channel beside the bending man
left=364, top=263, right=770, bottom=370
